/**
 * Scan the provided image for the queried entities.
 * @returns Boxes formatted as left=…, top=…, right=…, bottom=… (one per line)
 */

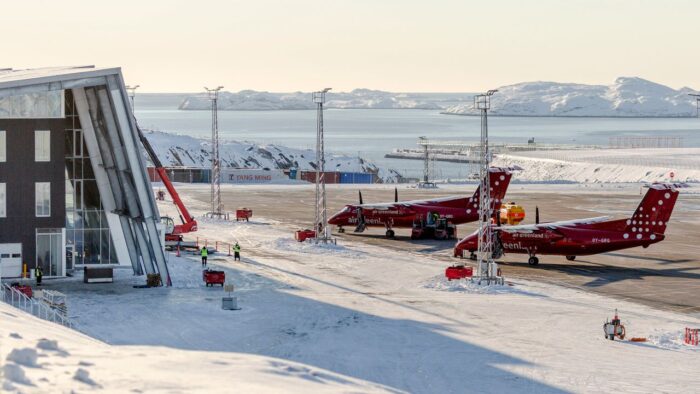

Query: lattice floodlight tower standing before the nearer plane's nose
left=474, top=90, right=503, bottom=285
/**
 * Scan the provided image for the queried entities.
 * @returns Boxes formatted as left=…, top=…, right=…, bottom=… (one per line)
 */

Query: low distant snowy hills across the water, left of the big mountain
left=179, top=89, right=460, bottom=111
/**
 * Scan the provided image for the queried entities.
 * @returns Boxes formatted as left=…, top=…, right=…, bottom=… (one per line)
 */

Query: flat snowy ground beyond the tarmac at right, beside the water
left=493, top=148, right=700, bottom=183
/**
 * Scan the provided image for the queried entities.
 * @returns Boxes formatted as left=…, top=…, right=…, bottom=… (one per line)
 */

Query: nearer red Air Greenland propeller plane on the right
left=454, top=183, right=686, bottom=265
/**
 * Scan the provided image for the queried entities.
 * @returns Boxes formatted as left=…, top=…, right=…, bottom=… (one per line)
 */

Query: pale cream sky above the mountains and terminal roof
left=0, top=0, right=700, bottom=92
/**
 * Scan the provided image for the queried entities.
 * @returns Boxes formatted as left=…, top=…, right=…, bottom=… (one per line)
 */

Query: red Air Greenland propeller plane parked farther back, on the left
left=328, top=167, right=518, bottom=238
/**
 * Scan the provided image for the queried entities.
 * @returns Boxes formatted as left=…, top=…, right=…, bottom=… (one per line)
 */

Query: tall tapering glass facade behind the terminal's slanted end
left=65, top=92, right=118, bottom=267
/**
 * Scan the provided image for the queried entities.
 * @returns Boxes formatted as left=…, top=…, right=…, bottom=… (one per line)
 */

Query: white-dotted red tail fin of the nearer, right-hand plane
left=626, top=183, right=687, bottom=235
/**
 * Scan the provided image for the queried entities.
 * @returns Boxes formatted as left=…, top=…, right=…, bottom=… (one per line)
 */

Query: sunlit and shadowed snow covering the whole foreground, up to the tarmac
left=0, top=190, right=700, bottom=393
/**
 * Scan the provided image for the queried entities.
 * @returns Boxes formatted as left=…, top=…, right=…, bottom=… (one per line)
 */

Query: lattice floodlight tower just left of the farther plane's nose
left=312, top=88, right=331, bottom=243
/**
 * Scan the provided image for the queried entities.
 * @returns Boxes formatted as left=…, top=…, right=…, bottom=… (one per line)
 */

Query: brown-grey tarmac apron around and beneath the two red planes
left=188, top=184, right=700, bottom=316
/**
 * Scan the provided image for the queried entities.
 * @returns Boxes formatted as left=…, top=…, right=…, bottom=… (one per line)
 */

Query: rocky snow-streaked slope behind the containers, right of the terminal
left=144, top=131, right=396, bottom=181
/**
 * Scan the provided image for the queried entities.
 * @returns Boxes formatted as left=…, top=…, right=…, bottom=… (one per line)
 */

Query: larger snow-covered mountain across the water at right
left=444, top=77, right=696, bottom=117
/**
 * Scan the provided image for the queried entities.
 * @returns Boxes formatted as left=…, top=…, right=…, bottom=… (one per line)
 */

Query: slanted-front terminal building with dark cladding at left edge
left=0, top=67, right=169, bottom=284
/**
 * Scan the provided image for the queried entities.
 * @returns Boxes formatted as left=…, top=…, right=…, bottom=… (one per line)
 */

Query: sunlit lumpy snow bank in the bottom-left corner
left=0, top=302, right=389, bottom=393
